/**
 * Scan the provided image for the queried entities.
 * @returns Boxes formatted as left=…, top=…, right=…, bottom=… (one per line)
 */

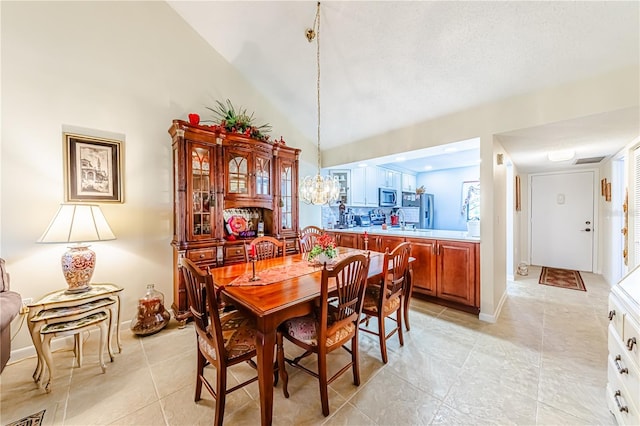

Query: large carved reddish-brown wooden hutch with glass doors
left=169, top=120, right=300, bottom=320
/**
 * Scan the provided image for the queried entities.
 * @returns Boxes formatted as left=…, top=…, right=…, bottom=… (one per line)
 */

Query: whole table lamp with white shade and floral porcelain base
left=38, top=204, right=116, bottom=293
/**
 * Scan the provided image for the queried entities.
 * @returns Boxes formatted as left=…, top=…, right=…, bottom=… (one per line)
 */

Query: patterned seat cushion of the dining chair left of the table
left=198, top=311, right=256, bottom=360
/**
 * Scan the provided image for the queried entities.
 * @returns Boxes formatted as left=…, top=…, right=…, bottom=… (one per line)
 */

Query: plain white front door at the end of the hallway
left=530, top=171, right=595, bottom=272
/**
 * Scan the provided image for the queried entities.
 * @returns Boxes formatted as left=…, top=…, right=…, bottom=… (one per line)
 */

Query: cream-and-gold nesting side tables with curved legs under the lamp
left=27, top=283, right=122, bottom=392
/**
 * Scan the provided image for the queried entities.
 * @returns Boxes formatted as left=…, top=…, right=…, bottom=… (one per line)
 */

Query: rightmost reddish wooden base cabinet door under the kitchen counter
left=436, top=240, right=476, bottom=306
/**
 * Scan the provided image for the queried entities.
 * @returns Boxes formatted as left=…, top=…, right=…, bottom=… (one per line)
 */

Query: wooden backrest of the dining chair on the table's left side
left=180, top=258, right=225, bottom=356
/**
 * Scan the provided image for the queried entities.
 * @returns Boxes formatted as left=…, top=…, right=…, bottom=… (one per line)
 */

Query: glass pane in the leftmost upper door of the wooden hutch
left=190, top=144, right=213, bottom=236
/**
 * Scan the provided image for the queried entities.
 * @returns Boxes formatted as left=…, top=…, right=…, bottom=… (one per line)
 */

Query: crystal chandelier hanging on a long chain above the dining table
left=299, top=2, right=340, bottom=205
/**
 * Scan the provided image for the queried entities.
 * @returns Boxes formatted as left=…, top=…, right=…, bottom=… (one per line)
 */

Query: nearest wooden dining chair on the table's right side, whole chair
left=276, top=254, right=369, bottom=417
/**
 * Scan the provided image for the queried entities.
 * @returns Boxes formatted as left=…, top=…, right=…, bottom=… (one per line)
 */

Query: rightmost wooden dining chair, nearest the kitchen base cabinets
left=360, top=243, right=411, bottom=364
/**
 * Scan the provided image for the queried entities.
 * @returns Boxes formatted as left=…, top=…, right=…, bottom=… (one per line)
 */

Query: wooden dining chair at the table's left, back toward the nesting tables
left=180, top=258, right=258, bottom=426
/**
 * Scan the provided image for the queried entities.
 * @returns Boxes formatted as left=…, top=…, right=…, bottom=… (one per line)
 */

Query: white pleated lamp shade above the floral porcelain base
left=38, top=204, right=116, bottom=243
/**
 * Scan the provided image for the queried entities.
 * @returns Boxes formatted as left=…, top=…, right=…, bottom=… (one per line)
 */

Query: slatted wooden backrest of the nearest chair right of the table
left=319, top=254, right=369, bottom=342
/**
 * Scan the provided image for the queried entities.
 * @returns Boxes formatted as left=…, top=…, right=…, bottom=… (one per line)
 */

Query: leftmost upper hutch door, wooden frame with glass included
left=186, top=141, right=217, bottom=241
